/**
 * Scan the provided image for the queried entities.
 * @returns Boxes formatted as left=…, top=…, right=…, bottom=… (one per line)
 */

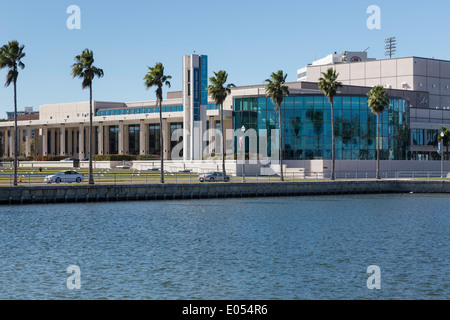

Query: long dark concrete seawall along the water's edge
left=0, top=180, right=450, bottom=205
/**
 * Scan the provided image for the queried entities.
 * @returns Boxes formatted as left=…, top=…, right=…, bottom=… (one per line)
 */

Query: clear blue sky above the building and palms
left=0, top=0, right=450, bottom=118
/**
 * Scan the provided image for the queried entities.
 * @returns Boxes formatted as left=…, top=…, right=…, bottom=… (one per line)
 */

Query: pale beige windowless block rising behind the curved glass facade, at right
left=298, top=52, right=450, bottom=160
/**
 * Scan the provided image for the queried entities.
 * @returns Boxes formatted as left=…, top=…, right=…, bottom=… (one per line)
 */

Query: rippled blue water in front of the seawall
left=0, top=195, right=450, bottom=300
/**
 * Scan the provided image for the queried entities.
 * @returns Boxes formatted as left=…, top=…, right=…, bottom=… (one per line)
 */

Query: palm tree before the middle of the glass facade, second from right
left=318, top=68, right=342, bottom=180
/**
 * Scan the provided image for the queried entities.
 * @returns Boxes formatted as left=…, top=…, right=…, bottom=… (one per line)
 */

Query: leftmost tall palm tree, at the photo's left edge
left=0, top=40, right=25, bottom=186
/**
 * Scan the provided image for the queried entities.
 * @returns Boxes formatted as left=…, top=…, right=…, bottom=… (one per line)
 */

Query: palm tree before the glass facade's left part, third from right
left=266, top=70, right=289, bottom=181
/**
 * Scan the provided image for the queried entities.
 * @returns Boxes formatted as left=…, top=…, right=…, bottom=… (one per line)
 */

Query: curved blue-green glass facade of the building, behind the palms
left=233, top=95, right=409, bottom=160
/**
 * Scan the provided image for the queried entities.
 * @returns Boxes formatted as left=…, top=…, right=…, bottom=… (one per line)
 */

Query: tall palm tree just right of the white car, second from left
left=71, top=49, right=104, bottom=184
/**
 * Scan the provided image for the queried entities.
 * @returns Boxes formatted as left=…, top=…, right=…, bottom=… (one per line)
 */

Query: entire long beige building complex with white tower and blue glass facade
left=0, top=52, right=450, bottom=176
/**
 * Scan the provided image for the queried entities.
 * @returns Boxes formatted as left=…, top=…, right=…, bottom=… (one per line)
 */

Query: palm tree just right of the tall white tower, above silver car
left=206, top=70, right=235, bottom=177
